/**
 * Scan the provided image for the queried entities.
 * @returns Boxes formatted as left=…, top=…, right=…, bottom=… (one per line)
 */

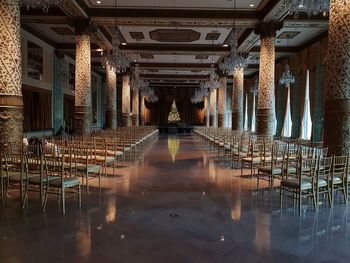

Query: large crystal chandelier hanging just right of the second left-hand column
left=102, top=0, right=130, bottom=73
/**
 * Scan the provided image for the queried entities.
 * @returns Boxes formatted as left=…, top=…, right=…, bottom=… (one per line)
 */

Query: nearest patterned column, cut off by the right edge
left=324, top=0, right=350, bottom=155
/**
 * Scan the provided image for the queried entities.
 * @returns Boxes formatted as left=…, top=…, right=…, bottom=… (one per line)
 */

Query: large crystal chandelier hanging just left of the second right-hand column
left=219, top=0, right=247, bottom=74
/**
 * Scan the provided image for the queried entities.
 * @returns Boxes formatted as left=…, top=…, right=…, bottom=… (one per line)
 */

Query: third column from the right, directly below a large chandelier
left=232, top=68, right=244, bottom=130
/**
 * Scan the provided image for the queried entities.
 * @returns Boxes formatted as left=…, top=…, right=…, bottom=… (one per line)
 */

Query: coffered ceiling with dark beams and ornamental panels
left=21, top=0, right=328, bottom=86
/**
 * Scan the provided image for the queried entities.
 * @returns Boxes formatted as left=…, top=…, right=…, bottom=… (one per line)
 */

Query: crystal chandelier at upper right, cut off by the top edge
left=285, top=0, right=329, bottom=19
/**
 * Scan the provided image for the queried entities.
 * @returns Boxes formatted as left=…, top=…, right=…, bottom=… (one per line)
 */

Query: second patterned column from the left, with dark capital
left=74, top=20, right=92, bottom=134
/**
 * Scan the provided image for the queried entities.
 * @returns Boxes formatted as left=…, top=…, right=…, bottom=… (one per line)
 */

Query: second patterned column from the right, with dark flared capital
left=254, top=21, right=283, bottom=135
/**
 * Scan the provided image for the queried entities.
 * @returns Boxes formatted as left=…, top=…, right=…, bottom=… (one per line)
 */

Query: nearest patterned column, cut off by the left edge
left=0, top=0, right=23, bottom=151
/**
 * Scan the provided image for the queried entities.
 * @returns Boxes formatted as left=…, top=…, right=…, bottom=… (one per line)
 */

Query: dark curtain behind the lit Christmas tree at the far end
left=145, top=87, right=203, bottom=125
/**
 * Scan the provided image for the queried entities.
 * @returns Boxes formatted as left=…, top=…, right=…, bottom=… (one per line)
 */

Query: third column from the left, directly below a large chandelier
left=106, top=66, right=117, bottom=129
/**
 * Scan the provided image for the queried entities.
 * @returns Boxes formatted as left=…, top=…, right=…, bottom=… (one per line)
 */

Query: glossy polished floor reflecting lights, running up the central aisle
left=0, top=135, right=350, bottom=263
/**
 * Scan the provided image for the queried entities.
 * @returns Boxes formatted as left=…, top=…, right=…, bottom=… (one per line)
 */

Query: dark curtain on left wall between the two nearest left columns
left=23, top=87, right=52, bottom=132
